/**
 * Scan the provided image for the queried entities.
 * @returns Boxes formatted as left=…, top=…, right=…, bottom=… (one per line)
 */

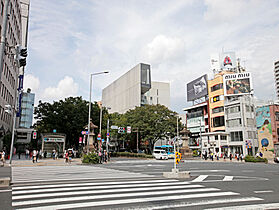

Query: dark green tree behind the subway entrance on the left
left=34, top=97, right=107, bottom=147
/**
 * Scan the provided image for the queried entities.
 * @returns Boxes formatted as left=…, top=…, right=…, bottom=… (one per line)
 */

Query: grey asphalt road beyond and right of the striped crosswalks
left=101, top=158, right=279, bottom=208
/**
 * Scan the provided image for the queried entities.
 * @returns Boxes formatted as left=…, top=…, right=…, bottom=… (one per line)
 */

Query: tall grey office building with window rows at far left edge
left=0, top=0, right=22, bottom=132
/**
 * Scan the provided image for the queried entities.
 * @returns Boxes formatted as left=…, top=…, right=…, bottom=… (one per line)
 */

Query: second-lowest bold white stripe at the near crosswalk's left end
left=12, top=188, right=220, bottom=206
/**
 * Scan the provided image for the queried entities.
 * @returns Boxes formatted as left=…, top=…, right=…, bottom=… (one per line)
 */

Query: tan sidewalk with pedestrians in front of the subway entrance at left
left=12, top=158, right=82, bottom=167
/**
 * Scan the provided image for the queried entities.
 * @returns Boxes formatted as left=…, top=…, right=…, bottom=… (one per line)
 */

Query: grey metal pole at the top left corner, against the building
left=0, top=0, right=9, bottom=82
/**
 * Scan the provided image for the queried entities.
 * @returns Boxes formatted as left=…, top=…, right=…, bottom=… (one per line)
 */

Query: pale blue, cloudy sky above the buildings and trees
left=24, top=0, right=279, bottom=113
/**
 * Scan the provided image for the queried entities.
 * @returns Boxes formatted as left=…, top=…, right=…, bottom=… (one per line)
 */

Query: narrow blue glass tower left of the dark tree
left=19, top=89, right=35, bottom=128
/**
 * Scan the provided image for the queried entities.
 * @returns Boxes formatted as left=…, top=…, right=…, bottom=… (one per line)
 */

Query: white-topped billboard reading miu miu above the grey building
left=223, top=72, right=253, bottom=96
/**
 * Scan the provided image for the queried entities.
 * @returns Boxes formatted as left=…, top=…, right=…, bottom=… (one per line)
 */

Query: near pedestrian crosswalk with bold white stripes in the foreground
left=12, top=177, right=263, bottom=210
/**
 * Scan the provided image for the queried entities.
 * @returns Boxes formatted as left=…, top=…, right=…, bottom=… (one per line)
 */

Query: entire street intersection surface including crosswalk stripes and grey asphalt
left=0, top=158, right=279, bottom=209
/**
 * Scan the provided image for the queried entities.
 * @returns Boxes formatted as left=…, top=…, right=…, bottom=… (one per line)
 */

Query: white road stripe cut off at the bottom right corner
left=207, top=203, right=279, bottom=210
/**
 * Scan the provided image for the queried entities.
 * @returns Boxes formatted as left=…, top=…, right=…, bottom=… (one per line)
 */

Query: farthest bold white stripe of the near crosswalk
left=13, top=179, right=179, bottom=190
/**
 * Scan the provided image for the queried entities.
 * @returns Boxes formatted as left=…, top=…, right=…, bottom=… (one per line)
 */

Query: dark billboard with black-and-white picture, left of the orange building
left=187, top=74, right=208, bottom=101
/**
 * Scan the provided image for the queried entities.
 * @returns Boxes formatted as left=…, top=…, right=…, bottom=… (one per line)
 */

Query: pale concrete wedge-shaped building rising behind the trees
left=102, top=63, right=170, bottom=113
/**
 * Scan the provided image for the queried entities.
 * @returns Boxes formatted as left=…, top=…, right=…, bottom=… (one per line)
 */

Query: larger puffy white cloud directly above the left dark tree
left=42, top=76, right=78, bottom=101
